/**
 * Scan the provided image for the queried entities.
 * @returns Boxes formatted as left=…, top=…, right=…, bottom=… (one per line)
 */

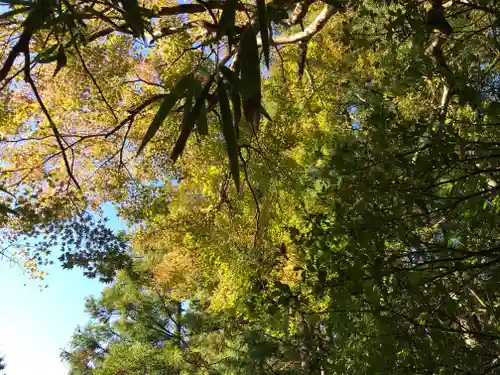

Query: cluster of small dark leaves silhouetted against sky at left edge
left=0, top=206, right=132, bottom=287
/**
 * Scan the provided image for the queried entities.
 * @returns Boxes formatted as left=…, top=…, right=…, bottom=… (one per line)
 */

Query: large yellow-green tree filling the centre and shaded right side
left=65, top=5, right=498, bottom=374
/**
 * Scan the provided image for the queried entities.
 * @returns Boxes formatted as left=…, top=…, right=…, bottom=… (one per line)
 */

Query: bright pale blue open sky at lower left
left=0, top=205, right=125, bottom=375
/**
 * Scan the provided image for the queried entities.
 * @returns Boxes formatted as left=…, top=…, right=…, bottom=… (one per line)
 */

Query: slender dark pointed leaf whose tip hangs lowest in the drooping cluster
left=217, top=80, right=240, bottom=190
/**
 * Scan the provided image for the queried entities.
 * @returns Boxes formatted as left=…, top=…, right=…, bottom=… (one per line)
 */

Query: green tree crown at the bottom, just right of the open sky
left=62, top=273, right=254, bottom=374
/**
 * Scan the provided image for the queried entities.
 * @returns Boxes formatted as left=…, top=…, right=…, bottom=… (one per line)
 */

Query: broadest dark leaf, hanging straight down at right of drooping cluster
left=241, top=30, right=261, bottom=130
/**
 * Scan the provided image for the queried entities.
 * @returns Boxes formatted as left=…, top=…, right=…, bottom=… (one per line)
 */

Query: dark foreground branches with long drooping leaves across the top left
left=0, top=0, right=344, bottom=194
